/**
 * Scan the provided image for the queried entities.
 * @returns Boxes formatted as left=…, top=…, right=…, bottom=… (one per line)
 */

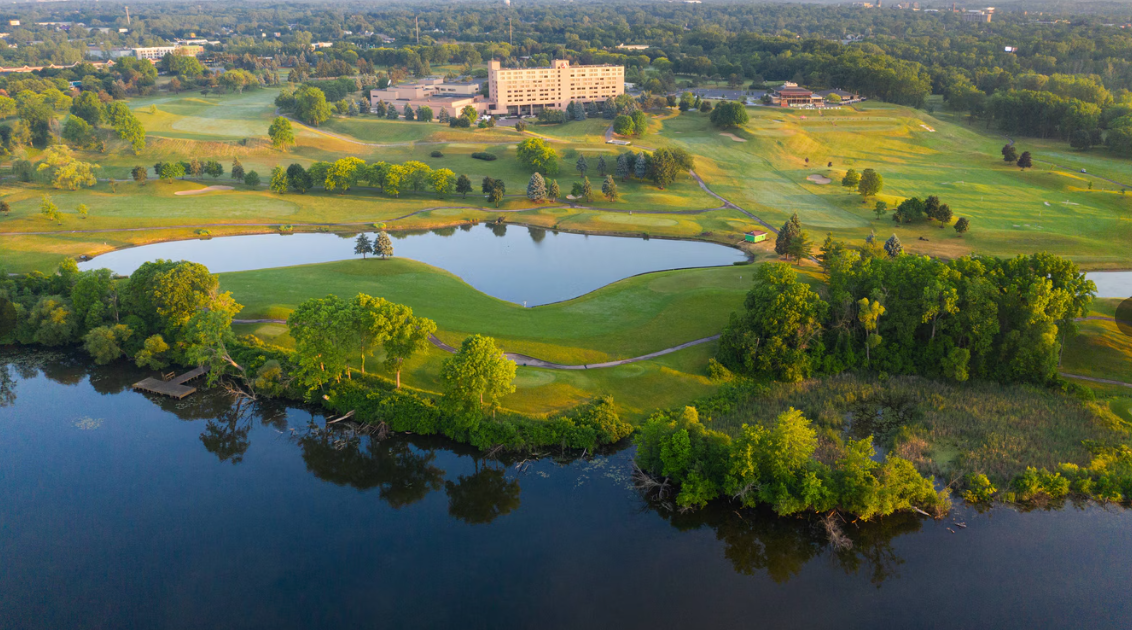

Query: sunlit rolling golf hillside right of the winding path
left=650, top=103, right=1132, bottom=268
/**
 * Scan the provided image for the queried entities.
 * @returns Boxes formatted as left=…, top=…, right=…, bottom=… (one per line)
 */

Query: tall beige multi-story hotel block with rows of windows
left=488, top=59, right=625, bottom=115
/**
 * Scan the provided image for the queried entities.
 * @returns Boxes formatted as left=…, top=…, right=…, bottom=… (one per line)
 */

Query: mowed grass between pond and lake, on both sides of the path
left=221, top=258, right=751, bottom=420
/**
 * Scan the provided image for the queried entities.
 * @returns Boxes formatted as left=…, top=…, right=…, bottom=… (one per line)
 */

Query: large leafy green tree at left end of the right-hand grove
left=719, top=262, right=827, bottom=382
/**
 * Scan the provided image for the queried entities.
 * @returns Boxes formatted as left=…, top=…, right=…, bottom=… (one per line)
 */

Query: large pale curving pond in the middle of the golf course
left=79, top=224, right=745, bottom=307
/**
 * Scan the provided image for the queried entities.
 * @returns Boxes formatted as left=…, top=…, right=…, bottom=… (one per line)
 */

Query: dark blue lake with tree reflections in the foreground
left=0, top=348, right=1132, bottom=629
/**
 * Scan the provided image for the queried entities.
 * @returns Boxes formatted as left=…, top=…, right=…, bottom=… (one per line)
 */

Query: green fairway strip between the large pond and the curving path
left=221, top=258, right=752, bottom=364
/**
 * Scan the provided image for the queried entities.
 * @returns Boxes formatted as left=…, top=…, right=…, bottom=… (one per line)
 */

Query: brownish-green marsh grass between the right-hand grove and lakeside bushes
left=701, top=374, right=1132, bottom=482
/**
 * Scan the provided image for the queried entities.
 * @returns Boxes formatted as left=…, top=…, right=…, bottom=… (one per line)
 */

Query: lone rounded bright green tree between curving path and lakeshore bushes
left=440, top=335, right=515, bottom=425
